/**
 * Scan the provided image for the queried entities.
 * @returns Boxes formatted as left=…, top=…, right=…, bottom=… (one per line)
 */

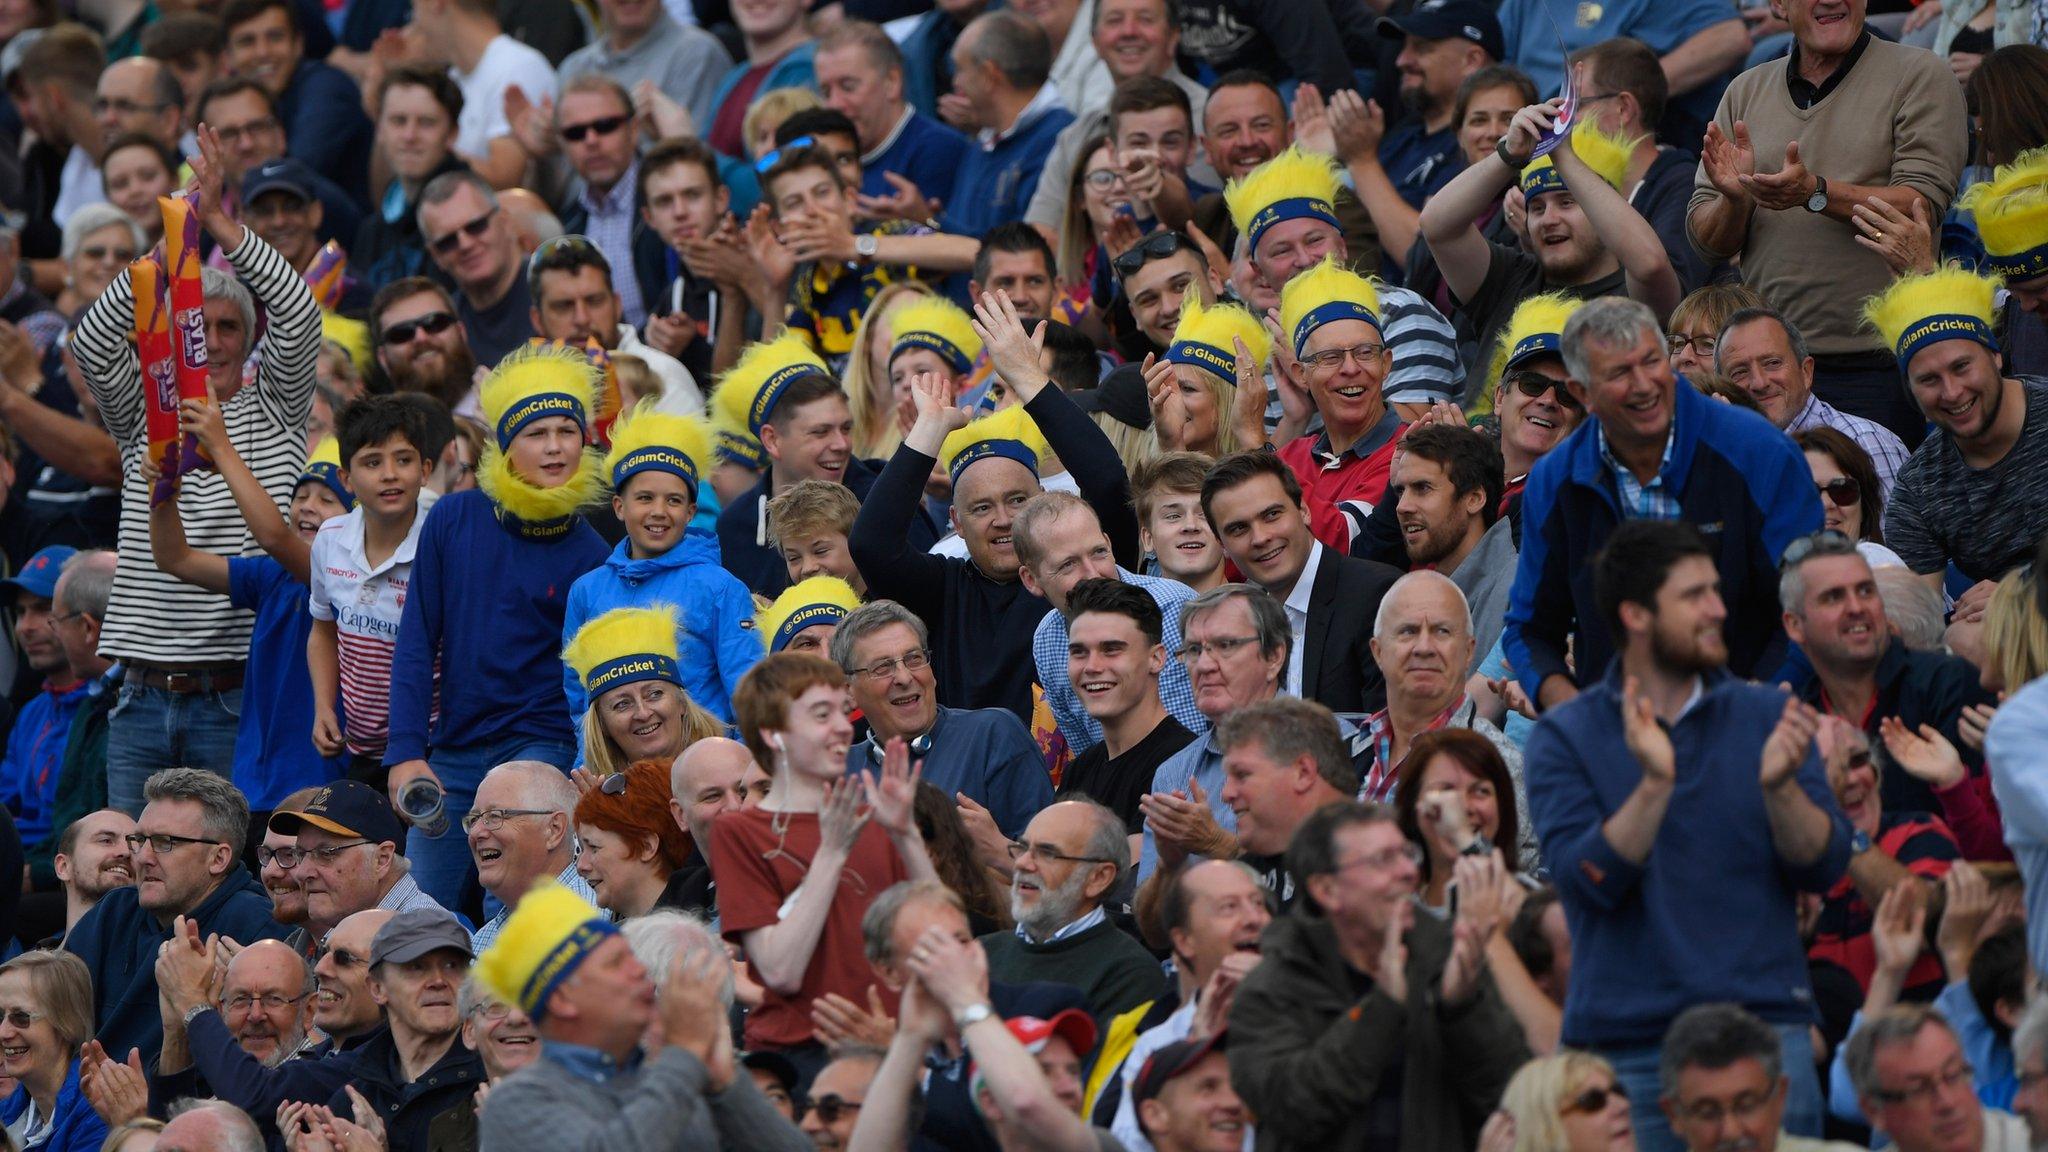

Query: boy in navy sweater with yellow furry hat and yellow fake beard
left=385, top=346, right=606, bottom=908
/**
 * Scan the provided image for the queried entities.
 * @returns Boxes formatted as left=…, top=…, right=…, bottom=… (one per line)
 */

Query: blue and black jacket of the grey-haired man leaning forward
left=1501, top=379, right=1821, bottom=699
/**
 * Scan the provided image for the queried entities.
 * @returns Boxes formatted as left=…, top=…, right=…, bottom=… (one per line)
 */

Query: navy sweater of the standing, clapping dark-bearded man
left=1522, top=660, right=1849, bottom=1047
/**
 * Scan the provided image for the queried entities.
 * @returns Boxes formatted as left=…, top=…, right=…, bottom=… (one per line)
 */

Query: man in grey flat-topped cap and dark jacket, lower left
left=311, top=908, right=485, bottom=1152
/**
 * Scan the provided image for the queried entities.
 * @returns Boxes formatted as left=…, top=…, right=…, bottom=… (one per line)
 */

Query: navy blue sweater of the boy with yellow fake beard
left=385, top=492, right=604, bottom=766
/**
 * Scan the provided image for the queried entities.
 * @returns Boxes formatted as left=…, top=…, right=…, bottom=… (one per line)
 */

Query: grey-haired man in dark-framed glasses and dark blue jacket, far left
left=63, top=769, right=287, bottom=1054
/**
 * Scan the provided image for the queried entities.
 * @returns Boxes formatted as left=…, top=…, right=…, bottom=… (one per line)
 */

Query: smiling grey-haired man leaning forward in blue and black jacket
left=1501, top=297, right=1821, bottom=709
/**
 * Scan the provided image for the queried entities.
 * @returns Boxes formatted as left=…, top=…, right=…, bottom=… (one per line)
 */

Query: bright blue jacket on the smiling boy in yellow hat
left=561, top=525, right=766, bottom=721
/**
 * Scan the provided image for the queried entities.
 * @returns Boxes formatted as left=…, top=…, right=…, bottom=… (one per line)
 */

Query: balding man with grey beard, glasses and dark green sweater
left=981, top=799, right=1161, bottom=1029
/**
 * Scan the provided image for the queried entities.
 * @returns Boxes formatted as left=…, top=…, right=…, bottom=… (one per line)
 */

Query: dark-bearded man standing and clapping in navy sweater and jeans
left=1526, top=518, right=1851, bottom=1148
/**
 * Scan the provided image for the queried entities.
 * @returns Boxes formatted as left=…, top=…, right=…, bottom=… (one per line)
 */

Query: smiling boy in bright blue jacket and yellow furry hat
left=561, top=408, right=762, bottom=732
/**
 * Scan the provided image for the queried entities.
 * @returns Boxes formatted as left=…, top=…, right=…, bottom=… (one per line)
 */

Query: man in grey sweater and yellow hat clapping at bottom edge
left=473, top=881, right=811, bottom=1152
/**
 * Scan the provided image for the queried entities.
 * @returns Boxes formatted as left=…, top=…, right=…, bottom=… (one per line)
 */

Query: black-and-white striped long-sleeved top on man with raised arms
left=72, top=230, right=319, bottom=664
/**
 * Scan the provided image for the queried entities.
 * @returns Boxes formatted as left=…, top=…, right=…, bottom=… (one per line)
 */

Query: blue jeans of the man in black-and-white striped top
left=106, top=676, right=242, bottom=816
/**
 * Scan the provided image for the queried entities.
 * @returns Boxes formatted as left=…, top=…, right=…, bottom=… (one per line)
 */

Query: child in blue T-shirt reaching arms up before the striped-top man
left=137, top=400, right=354, bottom=828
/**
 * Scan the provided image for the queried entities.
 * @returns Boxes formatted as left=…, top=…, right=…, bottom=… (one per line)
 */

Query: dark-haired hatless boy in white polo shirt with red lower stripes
left=305, top=396, right=434, bottom=791
